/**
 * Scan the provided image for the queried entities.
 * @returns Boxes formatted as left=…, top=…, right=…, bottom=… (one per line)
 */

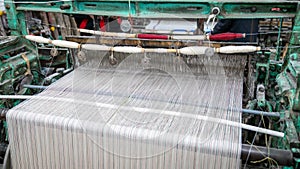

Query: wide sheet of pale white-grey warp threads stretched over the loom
left=7, top=54, right=245, bottom=168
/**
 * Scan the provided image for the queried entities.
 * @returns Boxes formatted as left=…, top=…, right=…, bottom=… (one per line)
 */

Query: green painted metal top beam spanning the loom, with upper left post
left=5, top=0, right=299, bottom=35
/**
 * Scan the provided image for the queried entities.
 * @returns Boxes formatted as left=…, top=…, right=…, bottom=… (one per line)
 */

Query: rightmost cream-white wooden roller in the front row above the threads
left=215, top=46, right=261, bottom=54
